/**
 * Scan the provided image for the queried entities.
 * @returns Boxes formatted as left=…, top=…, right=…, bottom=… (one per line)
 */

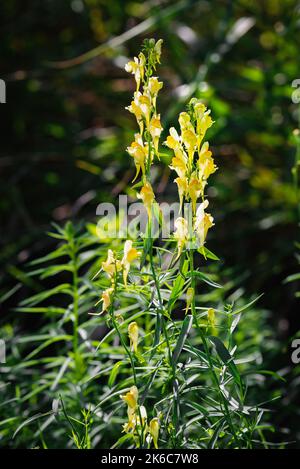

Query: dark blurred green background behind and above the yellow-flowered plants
left=0, top=0, right=300, bottom=444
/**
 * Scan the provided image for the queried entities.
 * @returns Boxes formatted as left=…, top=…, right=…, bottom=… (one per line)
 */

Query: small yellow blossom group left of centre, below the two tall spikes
left=101, top=239, right=140, bottom=312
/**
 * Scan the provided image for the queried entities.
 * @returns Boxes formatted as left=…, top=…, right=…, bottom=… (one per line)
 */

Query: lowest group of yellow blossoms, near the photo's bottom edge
left=121, top=386, right=159, bottom=449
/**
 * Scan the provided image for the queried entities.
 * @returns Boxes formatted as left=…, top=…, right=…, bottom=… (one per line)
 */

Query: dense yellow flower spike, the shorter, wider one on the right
left=165, top=98, right=217, bottom=257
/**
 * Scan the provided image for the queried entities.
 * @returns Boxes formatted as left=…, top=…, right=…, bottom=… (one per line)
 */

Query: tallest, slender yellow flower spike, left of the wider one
left=125, top=39, right=163, bottom=218
